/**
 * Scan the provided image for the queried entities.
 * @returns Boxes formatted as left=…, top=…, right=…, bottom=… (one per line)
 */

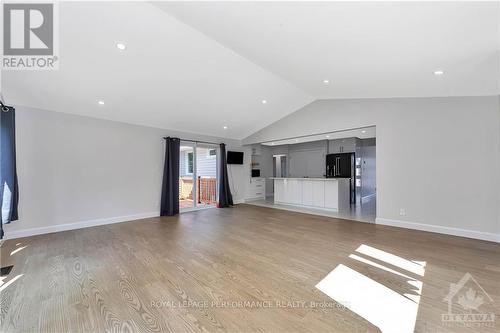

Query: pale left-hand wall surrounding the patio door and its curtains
left=4, top=107, right=250, bottom=238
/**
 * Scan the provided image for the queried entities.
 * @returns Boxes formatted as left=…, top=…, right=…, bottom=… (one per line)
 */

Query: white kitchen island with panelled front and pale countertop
left=271, top=178, right=350, bottom=212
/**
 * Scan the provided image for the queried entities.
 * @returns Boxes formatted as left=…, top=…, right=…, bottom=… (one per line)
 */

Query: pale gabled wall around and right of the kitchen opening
left=244, top=96, right=500, bottom=241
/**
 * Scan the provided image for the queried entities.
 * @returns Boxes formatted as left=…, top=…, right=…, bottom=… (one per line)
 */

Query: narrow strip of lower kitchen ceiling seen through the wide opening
left=262, top=126, right=377, bottom=146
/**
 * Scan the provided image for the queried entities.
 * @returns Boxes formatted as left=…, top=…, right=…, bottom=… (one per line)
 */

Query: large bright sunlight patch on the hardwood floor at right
left=316, top=244, right=426, bottom=333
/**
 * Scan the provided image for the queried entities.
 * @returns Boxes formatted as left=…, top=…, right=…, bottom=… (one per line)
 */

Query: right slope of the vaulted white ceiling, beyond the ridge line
left=156, top=1, right=500, bottom=98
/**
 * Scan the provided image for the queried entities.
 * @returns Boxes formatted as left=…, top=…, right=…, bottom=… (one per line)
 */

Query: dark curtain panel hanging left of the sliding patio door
left=160, top=137, right=181, bottom=216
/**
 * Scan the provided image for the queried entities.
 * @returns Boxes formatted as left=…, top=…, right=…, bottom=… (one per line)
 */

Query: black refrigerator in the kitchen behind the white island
left=326, top=153, right=356, bottom=204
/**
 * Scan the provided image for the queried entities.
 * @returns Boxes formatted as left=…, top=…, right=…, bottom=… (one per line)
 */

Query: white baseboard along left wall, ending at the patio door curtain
left=4, top=212, right=160, bottom=239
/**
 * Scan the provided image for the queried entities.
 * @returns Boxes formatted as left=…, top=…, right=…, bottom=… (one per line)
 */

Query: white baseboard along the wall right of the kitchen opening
left=375, top=217, right=500, bottom=243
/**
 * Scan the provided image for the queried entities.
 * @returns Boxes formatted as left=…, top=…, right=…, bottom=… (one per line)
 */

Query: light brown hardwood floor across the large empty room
left=0, top=205, right=500, bottom=333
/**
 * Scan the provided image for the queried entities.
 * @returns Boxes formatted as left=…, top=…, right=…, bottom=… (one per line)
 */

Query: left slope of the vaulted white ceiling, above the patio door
left=2, top=2, right=314, bottom=139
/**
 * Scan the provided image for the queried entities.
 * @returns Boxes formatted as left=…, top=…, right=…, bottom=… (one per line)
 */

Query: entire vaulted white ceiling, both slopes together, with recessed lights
left=1, top=2, right=500, bottom=139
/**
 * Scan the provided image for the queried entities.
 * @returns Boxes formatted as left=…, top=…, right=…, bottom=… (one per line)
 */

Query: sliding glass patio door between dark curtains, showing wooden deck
left=179, top=141, right=219, bottom=212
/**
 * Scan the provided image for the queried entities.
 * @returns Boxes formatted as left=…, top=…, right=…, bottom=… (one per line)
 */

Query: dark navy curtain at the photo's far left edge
left=0, top=104, right=19, bottom=239
